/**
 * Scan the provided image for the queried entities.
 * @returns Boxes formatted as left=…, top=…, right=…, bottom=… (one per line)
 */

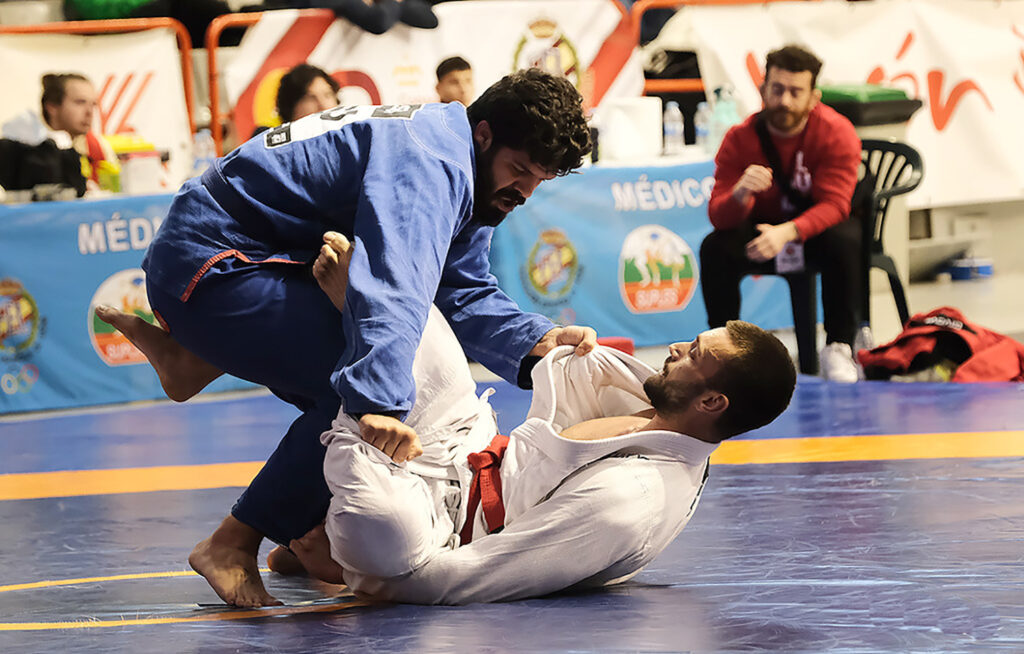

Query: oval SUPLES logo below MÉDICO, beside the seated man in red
left=618, top=225, right=697, bottom=313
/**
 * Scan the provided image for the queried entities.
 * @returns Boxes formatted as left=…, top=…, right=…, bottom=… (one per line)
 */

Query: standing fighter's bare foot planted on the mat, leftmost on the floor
left=188, top=538, right=281, bottom=607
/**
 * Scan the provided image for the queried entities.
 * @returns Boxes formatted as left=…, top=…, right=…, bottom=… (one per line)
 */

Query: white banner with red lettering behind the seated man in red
left=652, top=0, right=1024, bottom=208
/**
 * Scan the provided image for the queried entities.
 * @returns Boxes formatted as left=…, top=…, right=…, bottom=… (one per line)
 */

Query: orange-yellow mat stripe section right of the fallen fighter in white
left=711, top=431, right=1024, bottom=465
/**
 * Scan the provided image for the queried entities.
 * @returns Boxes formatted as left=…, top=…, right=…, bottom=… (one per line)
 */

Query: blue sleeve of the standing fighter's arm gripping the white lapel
left=435, top=225, right=555, bottom=384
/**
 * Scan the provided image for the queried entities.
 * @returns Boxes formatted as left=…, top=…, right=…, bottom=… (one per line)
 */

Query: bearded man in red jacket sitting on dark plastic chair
left=700, top=45, right=862, bottom=382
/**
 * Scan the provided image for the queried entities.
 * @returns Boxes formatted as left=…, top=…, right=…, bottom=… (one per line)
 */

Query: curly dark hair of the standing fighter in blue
left=466, top=69, right=591, bottom=175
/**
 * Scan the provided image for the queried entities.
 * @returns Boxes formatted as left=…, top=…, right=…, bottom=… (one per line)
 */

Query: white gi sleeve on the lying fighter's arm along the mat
left=345, top=466, right=664, bottom=604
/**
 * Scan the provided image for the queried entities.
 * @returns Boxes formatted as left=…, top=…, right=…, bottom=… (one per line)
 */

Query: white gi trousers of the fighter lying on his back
left=321, top=307, right=498, bottom=578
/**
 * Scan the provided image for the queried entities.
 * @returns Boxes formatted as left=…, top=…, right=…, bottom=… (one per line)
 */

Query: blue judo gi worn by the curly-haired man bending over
left=142, top=102, right=554, bottom=543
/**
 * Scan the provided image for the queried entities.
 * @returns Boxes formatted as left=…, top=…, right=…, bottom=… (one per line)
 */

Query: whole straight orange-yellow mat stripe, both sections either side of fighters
left=0, top=431, right=1024, bottom=500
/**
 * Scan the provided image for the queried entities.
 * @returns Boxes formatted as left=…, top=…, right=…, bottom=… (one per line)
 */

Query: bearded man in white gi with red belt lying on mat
left=282, top=280, right=796, bottom=604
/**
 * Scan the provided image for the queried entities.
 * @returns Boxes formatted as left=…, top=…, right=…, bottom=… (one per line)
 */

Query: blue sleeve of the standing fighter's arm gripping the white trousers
left=331, top=143, right=471, bottom=420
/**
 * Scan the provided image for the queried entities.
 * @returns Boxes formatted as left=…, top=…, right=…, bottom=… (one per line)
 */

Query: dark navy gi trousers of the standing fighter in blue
left=148, top=260, right=345, bottom=546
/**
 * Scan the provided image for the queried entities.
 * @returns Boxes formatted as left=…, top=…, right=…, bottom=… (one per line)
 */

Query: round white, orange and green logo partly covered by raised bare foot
left=88, top=268, right=157, bottom=365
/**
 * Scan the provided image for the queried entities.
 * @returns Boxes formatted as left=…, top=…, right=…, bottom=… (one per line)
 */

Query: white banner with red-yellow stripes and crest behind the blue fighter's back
left=223, top=0, right=643, bottom=136
